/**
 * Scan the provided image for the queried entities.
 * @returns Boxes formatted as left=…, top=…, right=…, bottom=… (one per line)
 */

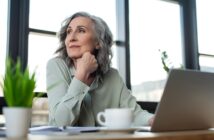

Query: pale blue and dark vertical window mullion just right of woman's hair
left=115, top=0, right=131, bottom=89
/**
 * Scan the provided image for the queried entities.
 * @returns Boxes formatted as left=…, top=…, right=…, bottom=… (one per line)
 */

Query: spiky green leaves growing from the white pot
left=1, top=58, right=36, bottom=107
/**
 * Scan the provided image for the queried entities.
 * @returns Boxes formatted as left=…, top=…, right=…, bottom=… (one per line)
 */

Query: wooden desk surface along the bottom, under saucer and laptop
left=0, top=130, right=214, bottom=140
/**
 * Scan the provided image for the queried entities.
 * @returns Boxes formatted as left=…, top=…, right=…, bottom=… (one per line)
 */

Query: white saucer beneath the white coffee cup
left=99, top=127, right=138, bottom=133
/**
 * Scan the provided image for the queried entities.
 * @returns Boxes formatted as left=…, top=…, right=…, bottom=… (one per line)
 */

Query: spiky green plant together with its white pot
left=1, top=59, right=36, bottom=138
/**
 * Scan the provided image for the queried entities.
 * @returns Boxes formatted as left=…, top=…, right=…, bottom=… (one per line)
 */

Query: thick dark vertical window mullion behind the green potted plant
left=7, top=0, right=29, bottom=68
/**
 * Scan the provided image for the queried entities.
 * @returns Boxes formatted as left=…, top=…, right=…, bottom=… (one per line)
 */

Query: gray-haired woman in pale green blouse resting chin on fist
left=47, top=12, right=153, bottom=126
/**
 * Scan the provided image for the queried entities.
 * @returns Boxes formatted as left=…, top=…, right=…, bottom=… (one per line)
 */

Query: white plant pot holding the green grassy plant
left=3, top=107, right=32, bottom=138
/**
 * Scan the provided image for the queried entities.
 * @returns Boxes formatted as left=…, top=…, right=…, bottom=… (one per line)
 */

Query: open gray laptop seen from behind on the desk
left=147, top=69, right=214, bottom=132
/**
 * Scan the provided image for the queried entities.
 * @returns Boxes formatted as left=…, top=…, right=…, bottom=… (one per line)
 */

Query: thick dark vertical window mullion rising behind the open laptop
left=179, top=0, right=199, bottom=69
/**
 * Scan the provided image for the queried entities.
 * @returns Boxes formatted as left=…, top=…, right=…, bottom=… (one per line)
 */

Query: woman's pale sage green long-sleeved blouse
left=47, top=58, right=153, bottom=126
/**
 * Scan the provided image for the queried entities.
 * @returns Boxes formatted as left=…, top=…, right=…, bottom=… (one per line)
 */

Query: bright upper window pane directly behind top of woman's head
left=29, top=0, right=116, bottom=33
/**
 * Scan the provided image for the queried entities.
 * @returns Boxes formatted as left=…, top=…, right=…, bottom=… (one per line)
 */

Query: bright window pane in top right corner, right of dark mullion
left=196, top=0, right=214, bottom=55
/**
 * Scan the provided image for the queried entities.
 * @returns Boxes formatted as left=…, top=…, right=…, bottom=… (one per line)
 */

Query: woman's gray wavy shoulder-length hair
left=56, top=12, right=113, bottom=75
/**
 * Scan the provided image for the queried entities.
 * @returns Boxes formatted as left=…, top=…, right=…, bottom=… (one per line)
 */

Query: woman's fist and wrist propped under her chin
left=75, top=52, right=98, bottom=85
